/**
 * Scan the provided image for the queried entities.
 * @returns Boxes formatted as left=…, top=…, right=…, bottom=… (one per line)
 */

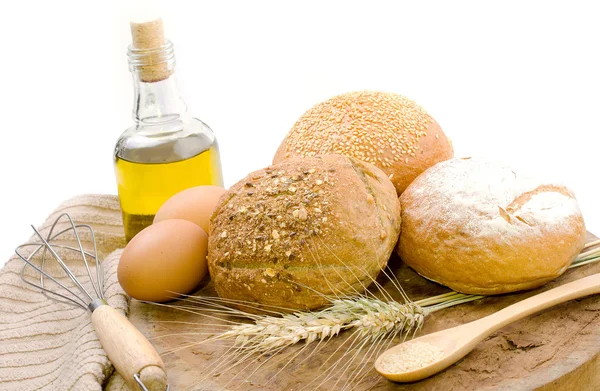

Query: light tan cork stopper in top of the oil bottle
left=130, top=19, right=173, bottom=83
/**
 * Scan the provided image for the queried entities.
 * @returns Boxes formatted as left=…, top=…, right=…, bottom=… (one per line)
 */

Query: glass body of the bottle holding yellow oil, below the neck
left=114, top=119, right=223, bottom=241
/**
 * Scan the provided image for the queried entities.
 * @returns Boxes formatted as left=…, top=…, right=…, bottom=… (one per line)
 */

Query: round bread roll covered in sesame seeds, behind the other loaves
left=273, top=91, right=454, bottom=194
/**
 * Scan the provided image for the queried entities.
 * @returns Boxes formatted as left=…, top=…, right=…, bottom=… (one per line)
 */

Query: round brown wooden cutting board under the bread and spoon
left=129, top=234, right=600, bottom=391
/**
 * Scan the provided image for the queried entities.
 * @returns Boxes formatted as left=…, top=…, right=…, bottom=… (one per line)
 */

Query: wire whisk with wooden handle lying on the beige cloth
left=15, top=213, right=169, bottom=391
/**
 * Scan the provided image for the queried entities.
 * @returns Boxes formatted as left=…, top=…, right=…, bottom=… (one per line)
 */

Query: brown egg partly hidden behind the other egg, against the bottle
left=154, top=186, right=226, bottom=233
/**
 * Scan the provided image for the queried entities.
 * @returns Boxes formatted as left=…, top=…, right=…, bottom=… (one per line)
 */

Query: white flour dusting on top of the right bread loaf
left=405, top=158, right=581, bottom=235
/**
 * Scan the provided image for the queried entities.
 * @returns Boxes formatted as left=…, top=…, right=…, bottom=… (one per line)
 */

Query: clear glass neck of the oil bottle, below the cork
left=132, top=72, right=187, bottom=124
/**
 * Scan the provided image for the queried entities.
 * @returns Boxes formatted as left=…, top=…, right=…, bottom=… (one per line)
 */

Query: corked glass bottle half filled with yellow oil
left=114, top=20, right=223, bottom=241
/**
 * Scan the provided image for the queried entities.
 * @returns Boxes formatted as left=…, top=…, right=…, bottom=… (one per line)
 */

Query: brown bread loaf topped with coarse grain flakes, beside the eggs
left=208, top=155, right=400, bottom=310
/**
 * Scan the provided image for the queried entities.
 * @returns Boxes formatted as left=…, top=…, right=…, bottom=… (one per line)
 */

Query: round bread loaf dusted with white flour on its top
left=397, top=158, right=586, bottom=295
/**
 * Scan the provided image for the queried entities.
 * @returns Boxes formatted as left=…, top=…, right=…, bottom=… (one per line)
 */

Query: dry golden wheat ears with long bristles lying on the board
left=154, top=240, right=600, bottom=390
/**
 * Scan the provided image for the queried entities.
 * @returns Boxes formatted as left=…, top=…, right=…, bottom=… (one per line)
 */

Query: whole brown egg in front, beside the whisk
left=117, top=219, right=208, bottom=302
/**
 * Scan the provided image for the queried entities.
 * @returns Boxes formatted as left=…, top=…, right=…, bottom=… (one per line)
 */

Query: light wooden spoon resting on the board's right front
left=375, top=273, right=600, bottom=383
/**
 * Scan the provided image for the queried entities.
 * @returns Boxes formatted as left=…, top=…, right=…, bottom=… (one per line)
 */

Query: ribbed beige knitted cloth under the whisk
left=0, top=195, right=128, bottom=391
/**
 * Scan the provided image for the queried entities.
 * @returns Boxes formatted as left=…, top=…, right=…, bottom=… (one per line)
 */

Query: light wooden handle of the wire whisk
left=92, top=305, right=167, bottom=391
